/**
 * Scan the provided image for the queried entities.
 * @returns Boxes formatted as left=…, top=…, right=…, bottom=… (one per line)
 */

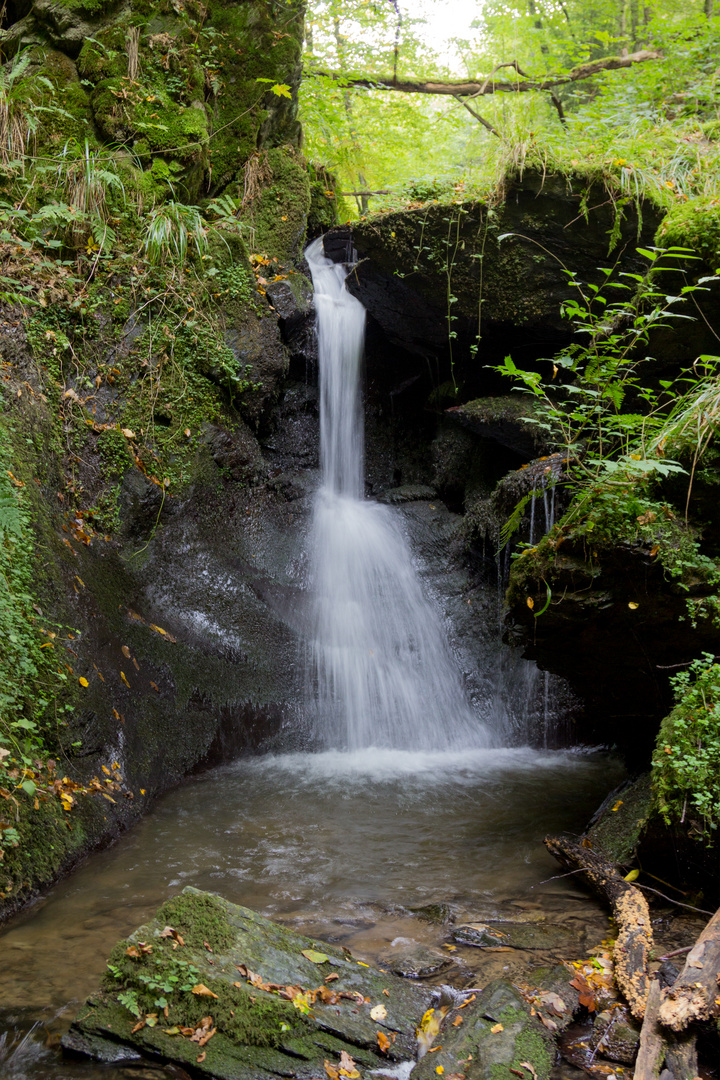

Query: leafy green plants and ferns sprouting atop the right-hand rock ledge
left=495, top=245, right=702, bottom=490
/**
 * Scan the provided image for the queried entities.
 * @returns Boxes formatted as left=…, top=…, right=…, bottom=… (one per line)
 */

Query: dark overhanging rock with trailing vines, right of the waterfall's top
left=325, top=173, right=660, bottom=383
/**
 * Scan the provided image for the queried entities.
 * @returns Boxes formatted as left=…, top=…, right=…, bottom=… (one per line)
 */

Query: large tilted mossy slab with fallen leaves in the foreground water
left=64, top=888, right=427, bottom=1080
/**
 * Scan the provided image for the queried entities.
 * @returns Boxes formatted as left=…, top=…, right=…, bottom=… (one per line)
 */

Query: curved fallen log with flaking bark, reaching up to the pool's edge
left=545, top=836, right=653, bottom=1020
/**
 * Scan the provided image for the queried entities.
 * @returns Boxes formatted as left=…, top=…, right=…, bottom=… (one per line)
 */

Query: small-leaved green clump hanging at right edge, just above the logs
left=652, top=652, right=720, bottom=843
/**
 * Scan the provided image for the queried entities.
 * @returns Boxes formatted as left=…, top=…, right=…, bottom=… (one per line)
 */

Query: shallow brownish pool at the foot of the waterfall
left=0, top=750, right=623, bottom=1080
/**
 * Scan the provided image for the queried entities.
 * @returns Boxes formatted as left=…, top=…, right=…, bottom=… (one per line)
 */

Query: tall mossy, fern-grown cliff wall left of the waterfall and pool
left=0, top=0, right=331, bottom=914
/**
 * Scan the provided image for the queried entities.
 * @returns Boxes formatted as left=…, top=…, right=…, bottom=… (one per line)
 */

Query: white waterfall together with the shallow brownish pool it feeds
left=0, top=242, right=622, bottom=1080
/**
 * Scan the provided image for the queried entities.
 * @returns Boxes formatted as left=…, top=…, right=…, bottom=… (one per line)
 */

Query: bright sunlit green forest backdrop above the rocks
left=301, top=0, right=720, bottom=219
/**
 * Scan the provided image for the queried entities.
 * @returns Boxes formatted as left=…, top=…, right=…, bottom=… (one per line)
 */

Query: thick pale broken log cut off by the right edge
left=660, top=909, right=720, bottom=1031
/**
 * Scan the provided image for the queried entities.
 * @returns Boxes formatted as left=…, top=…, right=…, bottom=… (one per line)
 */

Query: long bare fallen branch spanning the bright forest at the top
left=308, top=49, right=662, bottom=97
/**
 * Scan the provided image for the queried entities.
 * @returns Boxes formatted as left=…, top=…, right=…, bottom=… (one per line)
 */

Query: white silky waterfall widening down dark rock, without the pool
left=305, top=239, right=489, bottom=751
